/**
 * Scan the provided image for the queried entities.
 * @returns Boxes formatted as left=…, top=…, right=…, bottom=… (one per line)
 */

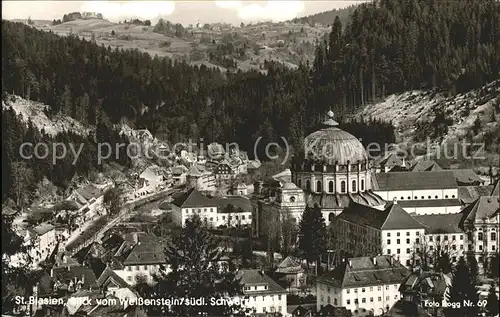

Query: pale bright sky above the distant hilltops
left=2, top=0, right=363, bottom=25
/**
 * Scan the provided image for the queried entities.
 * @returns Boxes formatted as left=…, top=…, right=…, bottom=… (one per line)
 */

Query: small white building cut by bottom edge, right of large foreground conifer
left=237, top=270, right=287, bottom=316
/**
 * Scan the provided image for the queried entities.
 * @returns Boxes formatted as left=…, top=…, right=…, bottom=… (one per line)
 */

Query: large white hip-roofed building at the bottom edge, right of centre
left=316, top=255, right=411, bottom=316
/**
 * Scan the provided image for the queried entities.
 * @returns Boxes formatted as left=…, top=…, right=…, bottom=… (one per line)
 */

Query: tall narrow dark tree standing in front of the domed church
left=299, top=205, right=326, bottom=268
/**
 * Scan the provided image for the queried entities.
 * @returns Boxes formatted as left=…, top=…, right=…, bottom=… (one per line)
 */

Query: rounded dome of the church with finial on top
left=304, top=111, right=368, bottom=165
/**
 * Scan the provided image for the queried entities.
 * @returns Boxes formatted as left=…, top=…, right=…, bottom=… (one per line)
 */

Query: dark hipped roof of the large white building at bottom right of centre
left=317, top=255, right=411, bottom=288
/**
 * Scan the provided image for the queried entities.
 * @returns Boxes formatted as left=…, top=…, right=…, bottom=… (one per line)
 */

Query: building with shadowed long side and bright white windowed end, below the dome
left=334, top=201, right=426, bottom=266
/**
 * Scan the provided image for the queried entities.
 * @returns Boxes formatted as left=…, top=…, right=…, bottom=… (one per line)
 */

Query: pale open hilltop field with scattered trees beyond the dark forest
left=26, top=19, right=330, bottom=71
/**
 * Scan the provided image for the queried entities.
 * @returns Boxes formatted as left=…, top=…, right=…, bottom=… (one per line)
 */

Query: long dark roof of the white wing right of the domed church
left=372, top=171, right=457, bottom=191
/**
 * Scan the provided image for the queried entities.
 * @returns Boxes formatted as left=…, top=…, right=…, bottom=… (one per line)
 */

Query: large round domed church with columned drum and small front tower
left=277, top=111, right=386, bottom=224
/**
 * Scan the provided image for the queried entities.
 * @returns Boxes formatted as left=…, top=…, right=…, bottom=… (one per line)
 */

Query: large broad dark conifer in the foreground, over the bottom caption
left=141, top=215, right=246, bottom=316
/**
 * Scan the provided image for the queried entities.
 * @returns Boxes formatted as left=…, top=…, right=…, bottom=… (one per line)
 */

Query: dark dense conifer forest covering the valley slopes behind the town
left=2, top=0, right=500, bottom=204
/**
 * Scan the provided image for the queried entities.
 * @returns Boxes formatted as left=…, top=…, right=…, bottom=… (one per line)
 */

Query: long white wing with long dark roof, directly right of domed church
left=373, top=171, right=462, bottom=215
